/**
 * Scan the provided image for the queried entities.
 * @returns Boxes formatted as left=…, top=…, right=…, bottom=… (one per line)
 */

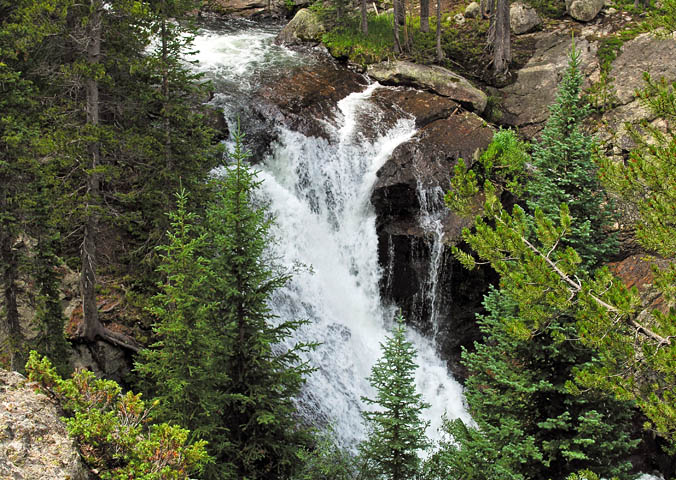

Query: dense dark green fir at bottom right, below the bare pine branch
left=433, top=290, right=638, bottom=479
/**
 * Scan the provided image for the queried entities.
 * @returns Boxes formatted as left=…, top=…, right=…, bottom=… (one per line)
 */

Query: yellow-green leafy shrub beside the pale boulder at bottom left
left=26, top=351, right=210, bottom=480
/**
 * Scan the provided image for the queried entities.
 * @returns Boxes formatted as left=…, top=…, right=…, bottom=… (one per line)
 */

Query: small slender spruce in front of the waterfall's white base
left=359, top=314, right=429, bottom=480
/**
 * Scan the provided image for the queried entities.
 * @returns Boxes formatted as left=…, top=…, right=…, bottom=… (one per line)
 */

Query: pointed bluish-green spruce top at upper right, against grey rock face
left=527, top=44, right=618, bottom=268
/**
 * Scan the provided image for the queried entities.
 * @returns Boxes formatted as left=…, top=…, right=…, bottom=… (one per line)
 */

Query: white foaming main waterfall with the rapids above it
left=196, top=24, right=469, bottom=447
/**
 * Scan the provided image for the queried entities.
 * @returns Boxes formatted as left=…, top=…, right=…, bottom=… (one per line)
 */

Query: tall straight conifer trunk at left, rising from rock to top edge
left=80, top=0, right=103, bottom=341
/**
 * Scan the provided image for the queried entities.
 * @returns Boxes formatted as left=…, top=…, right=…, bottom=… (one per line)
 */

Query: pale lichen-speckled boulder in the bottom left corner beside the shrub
left=0, top=369, right=90, bottom=480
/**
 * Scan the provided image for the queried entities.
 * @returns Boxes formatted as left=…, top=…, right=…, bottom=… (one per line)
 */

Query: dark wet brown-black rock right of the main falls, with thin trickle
left=371, top=110, right=494, bottom=376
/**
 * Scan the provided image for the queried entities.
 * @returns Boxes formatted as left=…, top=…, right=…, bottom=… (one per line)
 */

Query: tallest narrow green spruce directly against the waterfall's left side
left=205, top=127, right=312, bottom=480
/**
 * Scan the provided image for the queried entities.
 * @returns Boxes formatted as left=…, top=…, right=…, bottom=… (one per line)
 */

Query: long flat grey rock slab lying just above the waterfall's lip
left=367, top=61, right=488, bottom=114
